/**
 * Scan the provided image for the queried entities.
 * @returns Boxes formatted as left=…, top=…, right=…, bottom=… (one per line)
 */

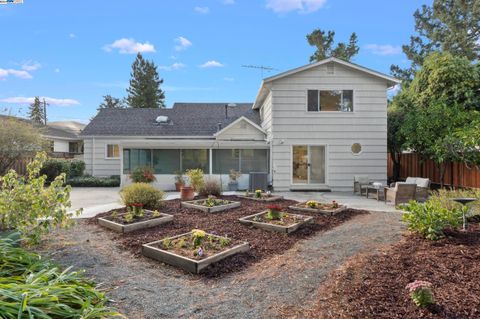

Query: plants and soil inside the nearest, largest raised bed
left=159, top=229, right=234, bottom=260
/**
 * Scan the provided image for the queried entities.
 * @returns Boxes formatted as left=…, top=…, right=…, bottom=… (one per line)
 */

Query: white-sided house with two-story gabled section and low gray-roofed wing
left=81, top=58, right=399, bottom=191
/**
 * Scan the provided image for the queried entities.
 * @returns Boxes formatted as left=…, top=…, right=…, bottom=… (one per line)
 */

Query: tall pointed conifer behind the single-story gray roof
left=127, top=53, right=165, bottom=108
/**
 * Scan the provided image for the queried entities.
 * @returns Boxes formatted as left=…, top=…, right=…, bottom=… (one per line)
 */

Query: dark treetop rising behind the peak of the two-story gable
left=307, top=29, right=360, bottom=62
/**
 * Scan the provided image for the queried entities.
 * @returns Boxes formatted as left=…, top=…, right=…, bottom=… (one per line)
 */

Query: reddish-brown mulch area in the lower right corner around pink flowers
left=300, top=223, right=480, bottom=319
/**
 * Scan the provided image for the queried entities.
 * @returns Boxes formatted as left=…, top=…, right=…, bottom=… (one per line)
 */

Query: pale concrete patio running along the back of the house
left=71, top=187, right=399, bottom=218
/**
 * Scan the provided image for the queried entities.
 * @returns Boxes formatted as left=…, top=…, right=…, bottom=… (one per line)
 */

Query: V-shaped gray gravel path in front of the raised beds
left=38, top=212, right=403, bottom=319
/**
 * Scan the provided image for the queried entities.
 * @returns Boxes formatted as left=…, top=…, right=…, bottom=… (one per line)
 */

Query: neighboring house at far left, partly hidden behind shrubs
left=44, top=121, right=85, bottom=158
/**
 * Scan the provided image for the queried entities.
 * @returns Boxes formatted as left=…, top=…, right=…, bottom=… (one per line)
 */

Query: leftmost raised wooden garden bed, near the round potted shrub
left=98, top=210, right=173, bottom=233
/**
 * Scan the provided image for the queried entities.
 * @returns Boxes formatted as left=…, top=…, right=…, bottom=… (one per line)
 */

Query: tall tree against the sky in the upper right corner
left=391, top=0, right=480, bottom=83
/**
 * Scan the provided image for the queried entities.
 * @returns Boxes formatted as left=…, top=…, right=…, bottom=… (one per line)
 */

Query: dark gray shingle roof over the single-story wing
left=81, top=103, right=260, bottom=136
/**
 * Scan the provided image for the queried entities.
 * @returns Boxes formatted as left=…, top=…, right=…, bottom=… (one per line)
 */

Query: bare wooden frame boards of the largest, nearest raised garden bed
left=142, top=233, right=250, bottom=274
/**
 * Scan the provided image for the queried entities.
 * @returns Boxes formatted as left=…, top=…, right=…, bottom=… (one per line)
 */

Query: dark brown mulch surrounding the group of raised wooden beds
left=88, top=196, right=368, bottom=277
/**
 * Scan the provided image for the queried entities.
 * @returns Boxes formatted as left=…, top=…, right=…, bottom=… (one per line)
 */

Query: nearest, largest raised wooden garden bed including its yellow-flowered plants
left=142, top=232, right=250, bottom=274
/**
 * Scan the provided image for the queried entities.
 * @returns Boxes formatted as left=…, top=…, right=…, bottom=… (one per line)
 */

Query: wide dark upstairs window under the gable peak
left=307, top=90, right=353, bottom=112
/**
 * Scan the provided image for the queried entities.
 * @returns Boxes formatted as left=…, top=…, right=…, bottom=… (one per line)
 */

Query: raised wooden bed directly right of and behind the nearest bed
left=239, top=210, right=313, bottom=234
